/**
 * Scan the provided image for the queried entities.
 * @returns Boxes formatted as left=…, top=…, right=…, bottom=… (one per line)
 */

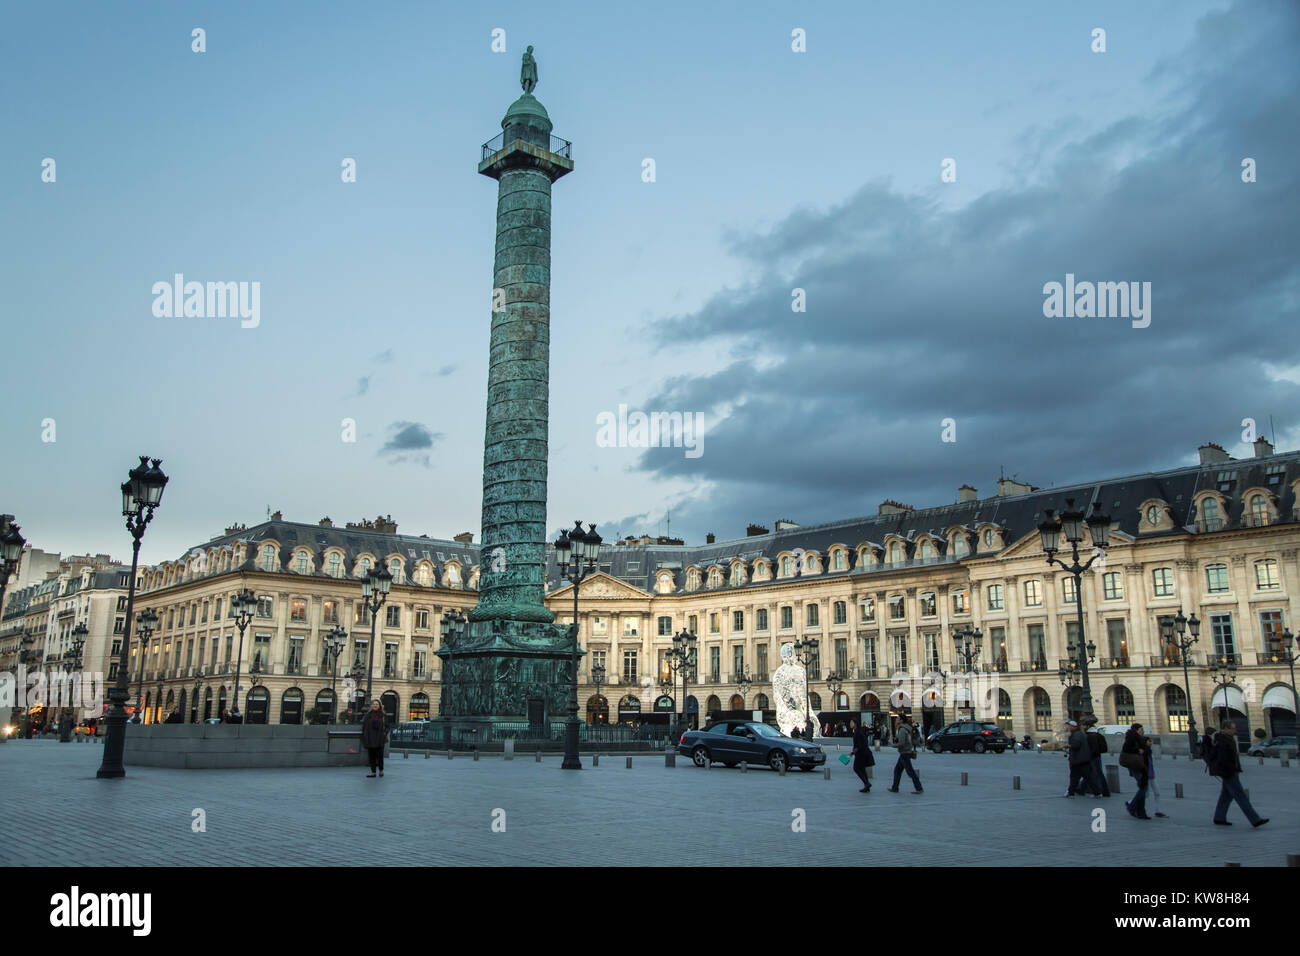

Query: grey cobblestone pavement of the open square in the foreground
left=0, top=741, right=1300, bottom=866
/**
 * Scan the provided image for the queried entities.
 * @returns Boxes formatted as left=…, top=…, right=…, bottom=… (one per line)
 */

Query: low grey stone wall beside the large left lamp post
left=122, top=723, right=387, bottom=770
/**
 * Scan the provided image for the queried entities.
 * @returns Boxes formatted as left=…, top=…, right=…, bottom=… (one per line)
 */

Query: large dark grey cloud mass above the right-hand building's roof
left=615, top=3, right=1300, bottom=546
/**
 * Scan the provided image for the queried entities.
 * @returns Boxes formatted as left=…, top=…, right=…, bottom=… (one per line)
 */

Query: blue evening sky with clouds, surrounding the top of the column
left=0, top=0, right=1300, bottom=562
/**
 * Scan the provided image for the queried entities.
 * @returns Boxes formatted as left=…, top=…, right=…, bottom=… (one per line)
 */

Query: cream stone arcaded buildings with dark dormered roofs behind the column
left=116, top=442, right=1300, bottom=739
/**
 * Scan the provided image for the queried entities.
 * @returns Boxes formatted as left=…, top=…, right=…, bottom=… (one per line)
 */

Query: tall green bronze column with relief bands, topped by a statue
left=437, top=47, right=573, bottom=739
